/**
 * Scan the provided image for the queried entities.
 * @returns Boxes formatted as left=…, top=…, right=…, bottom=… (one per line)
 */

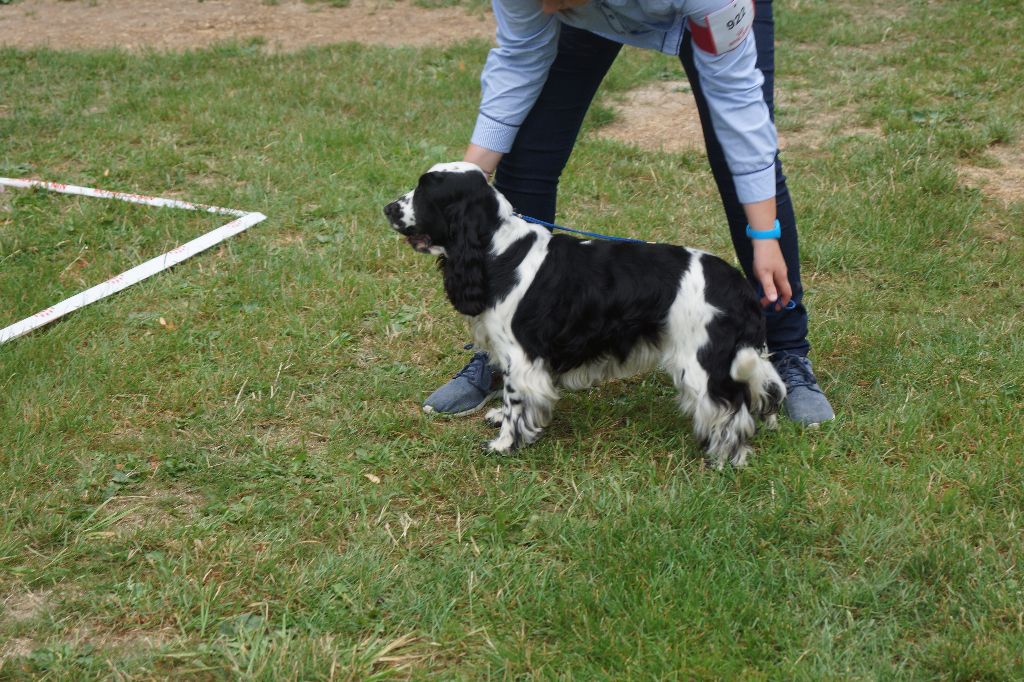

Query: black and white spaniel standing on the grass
left=384, top=162, right=785, bottom=467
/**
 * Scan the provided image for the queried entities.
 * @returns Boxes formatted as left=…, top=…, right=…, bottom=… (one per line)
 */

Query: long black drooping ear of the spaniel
left=441, top=184, right=498, bottom=315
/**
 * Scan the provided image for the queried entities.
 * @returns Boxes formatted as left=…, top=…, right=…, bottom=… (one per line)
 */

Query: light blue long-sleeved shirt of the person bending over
left=471, top=0, right=778, bottom=204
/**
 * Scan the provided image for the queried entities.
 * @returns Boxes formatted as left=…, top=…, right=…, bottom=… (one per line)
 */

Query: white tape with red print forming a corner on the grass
left=0, top=177, right=266, bottom=344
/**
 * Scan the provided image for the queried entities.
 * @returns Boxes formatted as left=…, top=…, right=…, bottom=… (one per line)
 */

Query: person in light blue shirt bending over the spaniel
left=423, top=0, right=835, bottom=426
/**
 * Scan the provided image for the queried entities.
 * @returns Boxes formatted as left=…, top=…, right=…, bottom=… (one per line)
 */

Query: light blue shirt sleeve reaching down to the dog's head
left=470, top=0, right=561, bottom=154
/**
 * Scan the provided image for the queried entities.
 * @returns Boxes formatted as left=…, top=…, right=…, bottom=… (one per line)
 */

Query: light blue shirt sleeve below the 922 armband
left=693, top=7, right=778, bottom=204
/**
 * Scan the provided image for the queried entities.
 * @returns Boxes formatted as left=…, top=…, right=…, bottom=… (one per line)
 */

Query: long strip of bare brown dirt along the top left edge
left=0, top=0, right=495, bottom=50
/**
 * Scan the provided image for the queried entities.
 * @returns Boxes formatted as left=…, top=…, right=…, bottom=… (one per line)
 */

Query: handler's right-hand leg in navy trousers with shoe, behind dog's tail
left=679, top=0, right=835, bottom=424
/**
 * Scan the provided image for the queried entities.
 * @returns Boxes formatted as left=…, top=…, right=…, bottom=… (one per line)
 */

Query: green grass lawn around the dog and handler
left=0, top=0, right=1024, bottom=680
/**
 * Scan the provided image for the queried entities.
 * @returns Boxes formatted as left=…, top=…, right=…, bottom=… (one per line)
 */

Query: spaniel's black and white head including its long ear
left=384, top=162, right=501, bottom=315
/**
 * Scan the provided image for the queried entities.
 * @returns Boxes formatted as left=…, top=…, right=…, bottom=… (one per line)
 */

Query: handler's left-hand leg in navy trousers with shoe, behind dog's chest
left=423, top=26, right=622, bottom=416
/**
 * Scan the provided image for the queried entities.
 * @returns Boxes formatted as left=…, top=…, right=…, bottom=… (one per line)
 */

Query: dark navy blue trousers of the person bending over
left=495, top=0, right=810, bottom=354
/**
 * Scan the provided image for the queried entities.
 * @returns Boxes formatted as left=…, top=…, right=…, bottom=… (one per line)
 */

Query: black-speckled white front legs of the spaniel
left=486, top=357, right=558, bottom=454
